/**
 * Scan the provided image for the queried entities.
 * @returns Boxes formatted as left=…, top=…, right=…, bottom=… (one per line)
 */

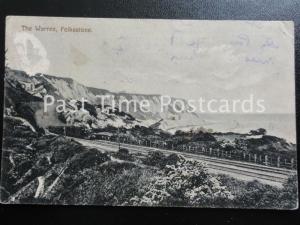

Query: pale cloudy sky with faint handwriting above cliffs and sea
left=6, top=17, right=295, bottom=113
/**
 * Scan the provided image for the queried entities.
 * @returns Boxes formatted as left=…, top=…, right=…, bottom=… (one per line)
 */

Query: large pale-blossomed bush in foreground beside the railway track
left=130, top=156, right=233, bottom=207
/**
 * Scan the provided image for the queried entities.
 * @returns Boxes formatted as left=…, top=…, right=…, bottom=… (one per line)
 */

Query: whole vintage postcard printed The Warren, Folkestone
left=1, top=16, right=298, bottom=209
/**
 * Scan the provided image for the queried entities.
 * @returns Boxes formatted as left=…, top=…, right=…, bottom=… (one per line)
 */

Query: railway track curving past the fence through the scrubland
left=73, top=138, right=296, bottom=186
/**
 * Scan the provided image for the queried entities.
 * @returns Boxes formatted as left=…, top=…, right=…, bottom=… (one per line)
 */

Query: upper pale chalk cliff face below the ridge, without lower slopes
left=33, top=71, right=198, bottom=122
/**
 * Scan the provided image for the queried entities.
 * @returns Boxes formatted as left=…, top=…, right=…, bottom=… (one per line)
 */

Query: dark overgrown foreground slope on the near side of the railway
left=1, top=118, right=297, bottom=209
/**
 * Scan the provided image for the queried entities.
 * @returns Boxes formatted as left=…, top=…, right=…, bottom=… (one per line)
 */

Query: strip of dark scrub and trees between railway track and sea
left=60, top=125, right=297, bottom=168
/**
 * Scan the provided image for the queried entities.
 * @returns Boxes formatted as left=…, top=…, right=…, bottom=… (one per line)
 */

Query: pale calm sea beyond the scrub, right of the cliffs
left=168, top=113, right=296, bottom=144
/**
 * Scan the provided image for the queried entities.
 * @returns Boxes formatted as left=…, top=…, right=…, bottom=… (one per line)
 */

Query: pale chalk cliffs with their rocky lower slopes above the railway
left=5, top=70, right=199, bottom=129
